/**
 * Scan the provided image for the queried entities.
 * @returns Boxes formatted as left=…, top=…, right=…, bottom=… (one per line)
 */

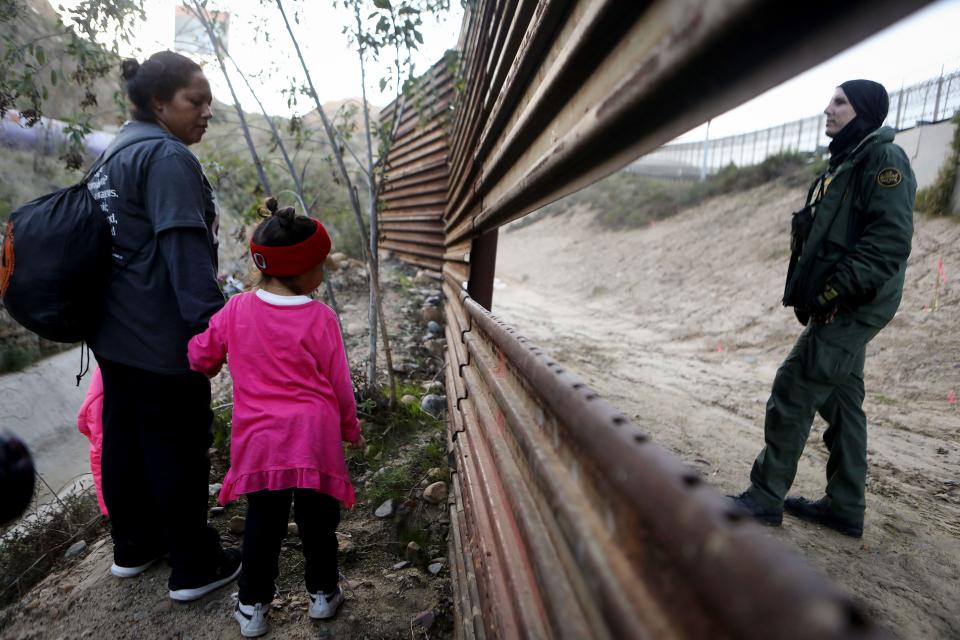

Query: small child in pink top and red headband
left=188, top=198, right=363, bottom=638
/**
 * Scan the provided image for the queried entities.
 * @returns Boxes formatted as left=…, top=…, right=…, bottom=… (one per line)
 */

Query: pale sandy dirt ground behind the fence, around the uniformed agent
left=493, top=185, right=960, bottom=638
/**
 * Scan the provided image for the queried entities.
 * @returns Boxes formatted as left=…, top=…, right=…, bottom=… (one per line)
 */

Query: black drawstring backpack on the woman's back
left=0, top=137, right=160, bottom=342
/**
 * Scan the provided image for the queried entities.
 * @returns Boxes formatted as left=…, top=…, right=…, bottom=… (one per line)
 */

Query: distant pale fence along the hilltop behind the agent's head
left=630, top=71, right=960, bottom=178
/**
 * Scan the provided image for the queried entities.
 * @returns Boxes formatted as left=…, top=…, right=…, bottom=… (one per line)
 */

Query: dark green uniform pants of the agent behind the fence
left=748, top=314, right=880, bottom=520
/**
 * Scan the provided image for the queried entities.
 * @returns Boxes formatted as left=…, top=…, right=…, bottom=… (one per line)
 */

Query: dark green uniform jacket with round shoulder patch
left=783, top=127, right=917, bottom=327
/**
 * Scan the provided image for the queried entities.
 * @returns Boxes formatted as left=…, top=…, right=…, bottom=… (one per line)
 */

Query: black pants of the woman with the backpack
left=98, top=358, right=220, bottom=589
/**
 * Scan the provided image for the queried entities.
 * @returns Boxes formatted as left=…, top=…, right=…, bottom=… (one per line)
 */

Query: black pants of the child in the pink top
left=237, top=489, right=340, bottom=604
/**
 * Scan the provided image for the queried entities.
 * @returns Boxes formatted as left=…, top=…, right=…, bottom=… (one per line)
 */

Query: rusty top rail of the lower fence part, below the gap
left=463, top=298, right=889, bottom=639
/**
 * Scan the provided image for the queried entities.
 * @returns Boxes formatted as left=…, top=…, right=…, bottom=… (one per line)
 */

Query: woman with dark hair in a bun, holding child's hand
left=88, top=51, right=240, bottom=600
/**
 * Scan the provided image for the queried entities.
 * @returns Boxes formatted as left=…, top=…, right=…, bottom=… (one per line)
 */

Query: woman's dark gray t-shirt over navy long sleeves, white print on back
left=87, top=121, right=223, bottom=374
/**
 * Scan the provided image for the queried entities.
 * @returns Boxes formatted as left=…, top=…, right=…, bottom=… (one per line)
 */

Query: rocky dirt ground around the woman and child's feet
left=0, top=261, right=453, bottom=640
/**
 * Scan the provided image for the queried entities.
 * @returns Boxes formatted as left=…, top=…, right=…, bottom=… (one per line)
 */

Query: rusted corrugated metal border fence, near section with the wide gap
left=384, top=0, right=924, bottom=639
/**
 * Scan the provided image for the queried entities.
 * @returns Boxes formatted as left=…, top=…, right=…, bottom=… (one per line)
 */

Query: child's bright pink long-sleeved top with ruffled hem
left=187, top=290, right=360, bottom=508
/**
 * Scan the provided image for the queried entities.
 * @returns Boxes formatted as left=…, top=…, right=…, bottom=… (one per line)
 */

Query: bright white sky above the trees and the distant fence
left=53, top=0, right=960, bottom=140
